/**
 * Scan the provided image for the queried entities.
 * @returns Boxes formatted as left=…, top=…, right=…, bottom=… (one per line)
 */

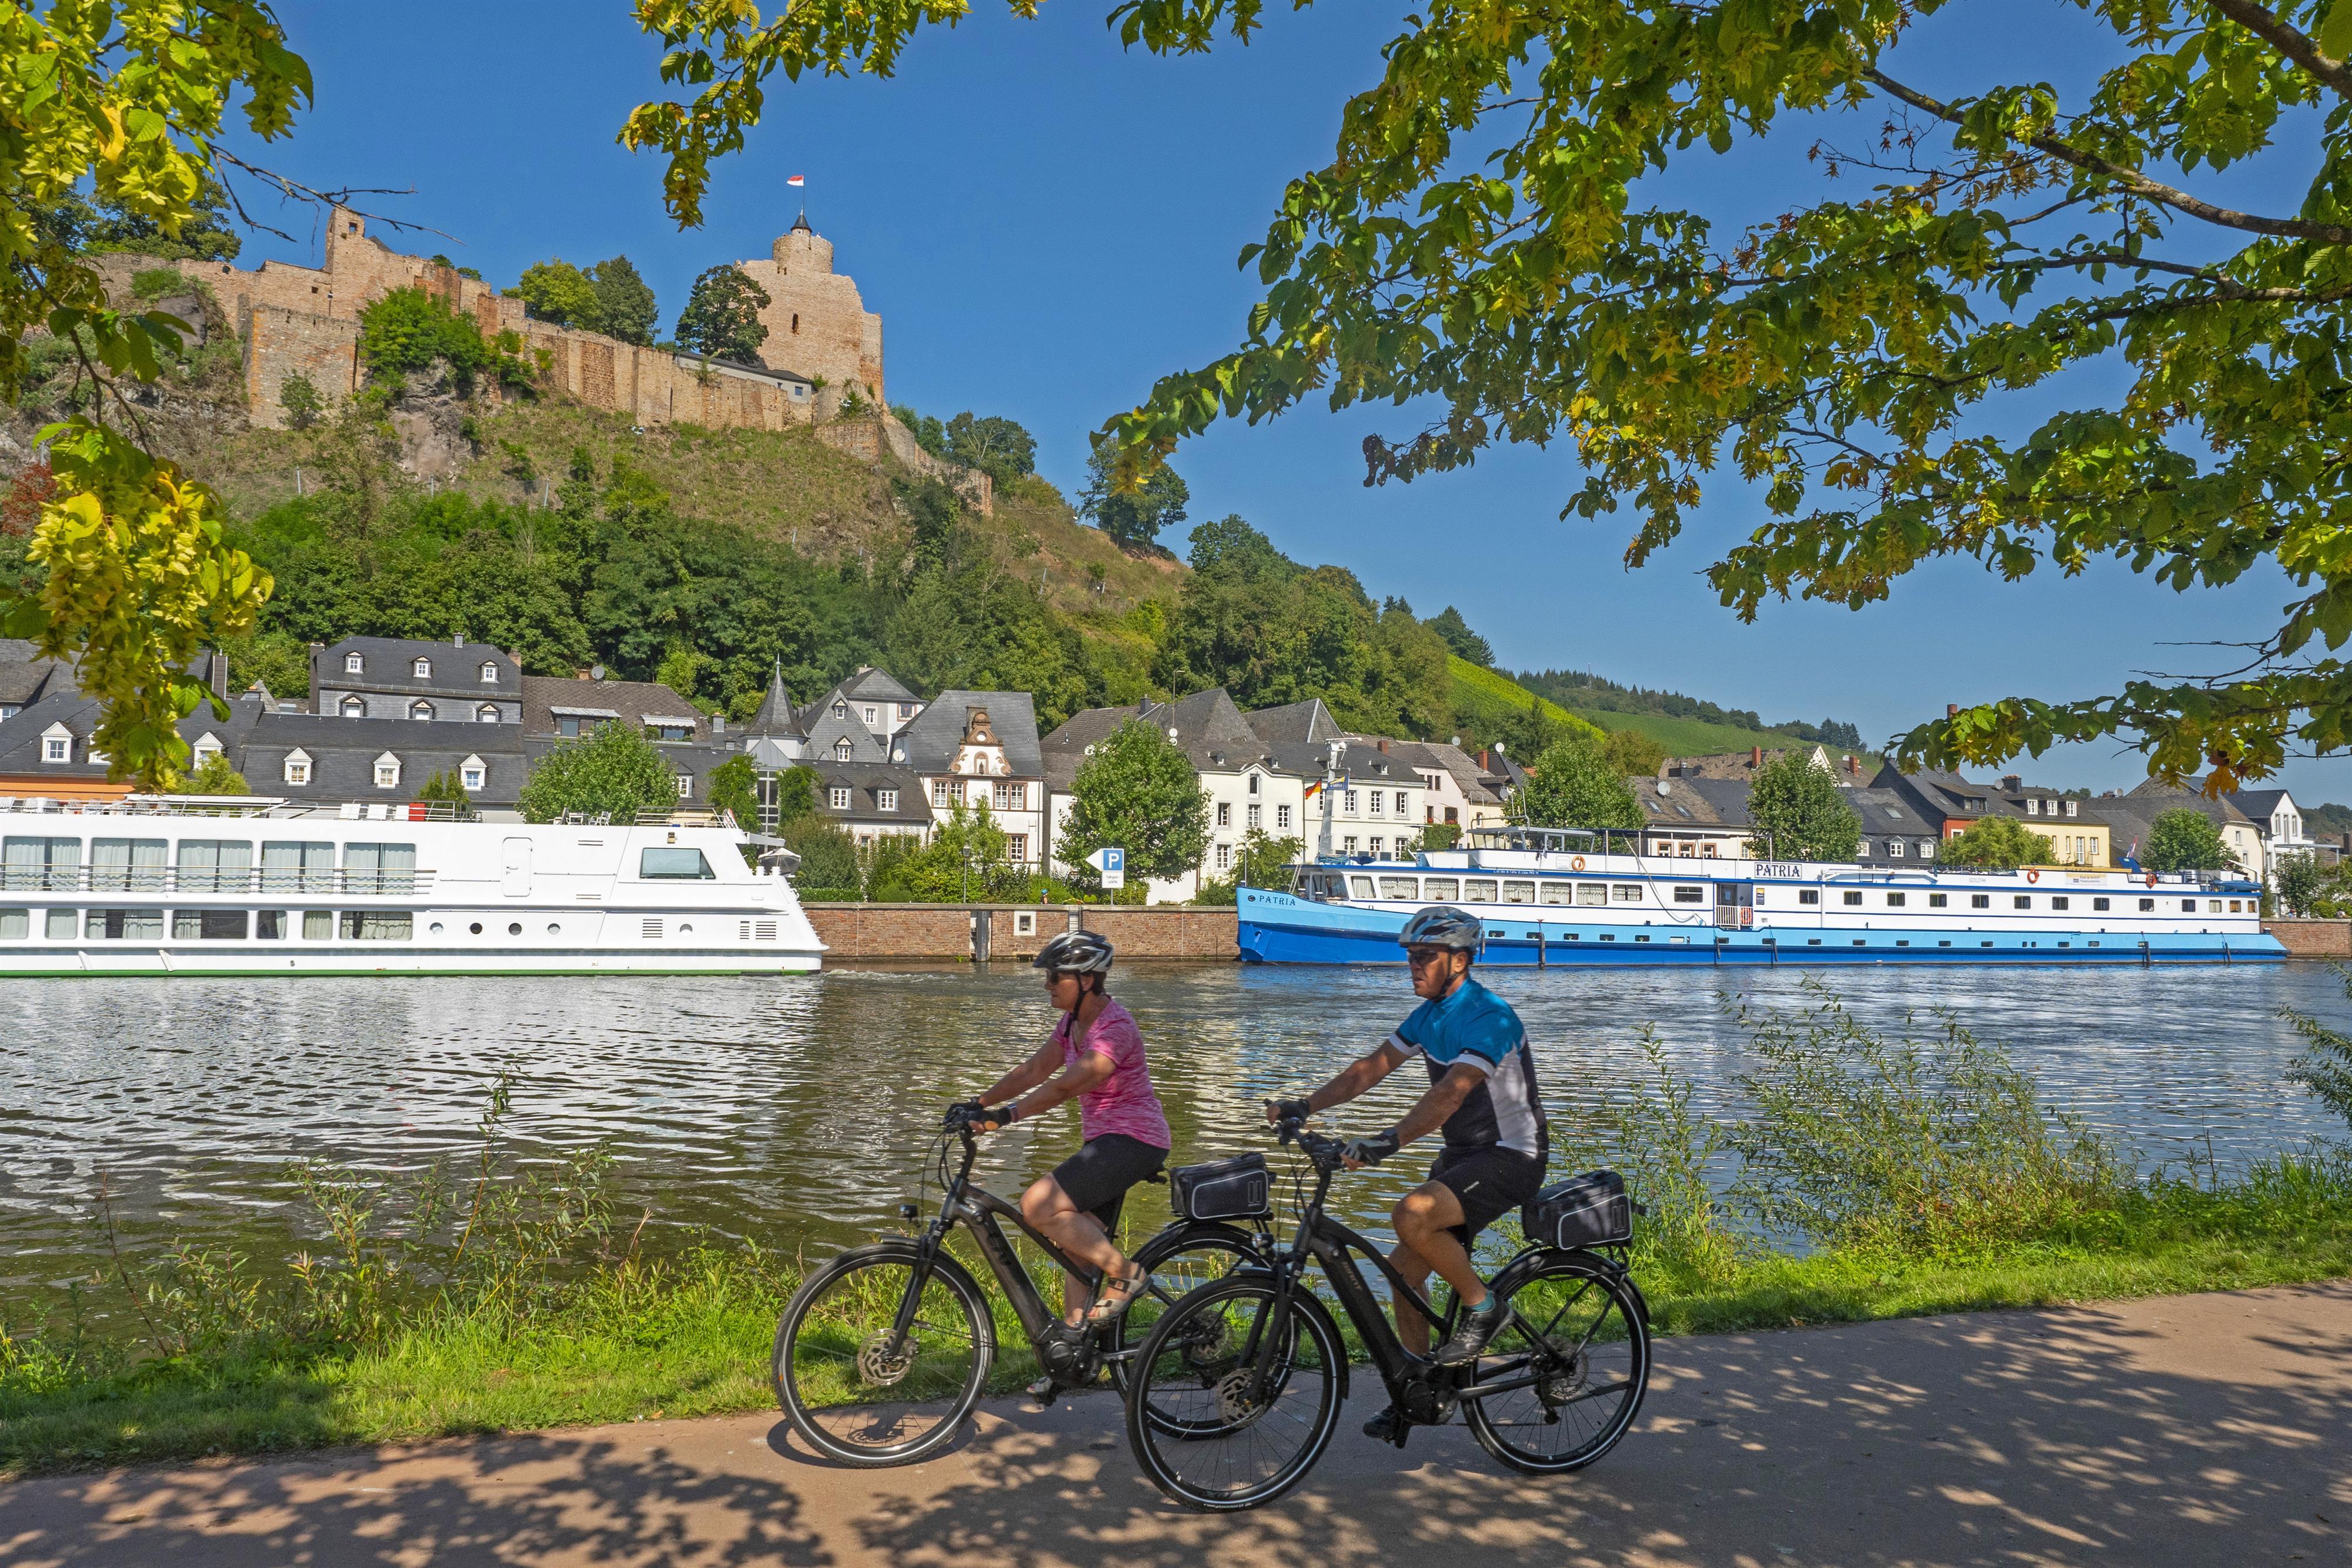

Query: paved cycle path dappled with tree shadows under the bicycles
left=0, top=1281, right=2352, bottom=1568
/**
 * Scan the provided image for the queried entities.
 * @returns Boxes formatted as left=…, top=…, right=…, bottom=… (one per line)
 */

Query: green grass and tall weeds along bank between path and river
left=14, top=992, right=2352, bottom=1476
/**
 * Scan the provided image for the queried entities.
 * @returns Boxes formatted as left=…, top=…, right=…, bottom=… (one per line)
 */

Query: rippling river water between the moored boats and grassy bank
left=0, top=964, right=2352, bottom=1316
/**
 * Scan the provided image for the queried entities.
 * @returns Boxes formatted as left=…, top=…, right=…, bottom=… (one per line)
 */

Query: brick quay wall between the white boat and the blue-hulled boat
left=804, top=902, right=1237, bottom=964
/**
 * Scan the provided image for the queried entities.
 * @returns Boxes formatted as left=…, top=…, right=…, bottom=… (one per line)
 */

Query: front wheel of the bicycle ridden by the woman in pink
left=774, top=1241, right=997, bottom=1467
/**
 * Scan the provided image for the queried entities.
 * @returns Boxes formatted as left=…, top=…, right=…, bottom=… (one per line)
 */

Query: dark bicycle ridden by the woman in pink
left=771, top=1126, right=1272, bottom=1467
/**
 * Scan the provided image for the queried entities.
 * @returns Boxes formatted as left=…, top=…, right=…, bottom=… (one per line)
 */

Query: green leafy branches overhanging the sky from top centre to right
left=623, top=0, right=2352, bottom=792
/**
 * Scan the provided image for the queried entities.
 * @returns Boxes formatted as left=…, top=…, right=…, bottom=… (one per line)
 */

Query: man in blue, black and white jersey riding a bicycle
left=1265, top=905, right=1550, bottom=1441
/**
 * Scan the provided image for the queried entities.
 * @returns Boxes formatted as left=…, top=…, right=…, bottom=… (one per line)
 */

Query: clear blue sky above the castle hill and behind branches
left=216, top=0, right=2352, bottom=799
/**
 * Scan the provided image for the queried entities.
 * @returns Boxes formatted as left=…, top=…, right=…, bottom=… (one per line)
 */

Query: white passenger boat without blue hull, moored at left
left=0, top=797, right=823, bottom=975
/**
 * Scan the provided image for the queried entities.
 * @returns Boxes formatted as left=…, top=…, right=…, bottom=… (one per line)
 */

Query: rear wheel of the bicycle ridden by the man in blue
left=1463, top=1253, right=1649, bottom=1474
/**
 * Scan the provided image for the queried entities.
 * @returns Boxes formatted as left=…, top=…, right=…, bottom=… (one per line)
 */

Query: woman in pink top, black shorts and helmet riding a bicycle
left=950, top=931, right=1174, bottom=1392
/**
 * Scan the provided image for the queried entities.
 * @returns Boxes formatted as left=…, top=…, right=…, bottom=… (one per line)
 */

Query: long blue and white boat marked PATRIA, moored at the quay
left=1240, top=827, right=2286, bottom=966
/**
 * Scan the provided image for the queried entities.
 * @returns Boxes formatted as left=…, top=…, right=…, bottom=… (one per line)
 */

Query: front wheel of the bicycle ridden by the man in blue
left=1127, top=1272, right=1348, bottom=1514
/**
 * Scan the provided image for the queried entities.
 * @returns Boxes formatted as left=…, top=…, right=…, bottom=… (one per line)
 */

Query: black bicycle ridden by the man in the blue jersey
left=1127, top=1121, right=1649, bottom=1512
